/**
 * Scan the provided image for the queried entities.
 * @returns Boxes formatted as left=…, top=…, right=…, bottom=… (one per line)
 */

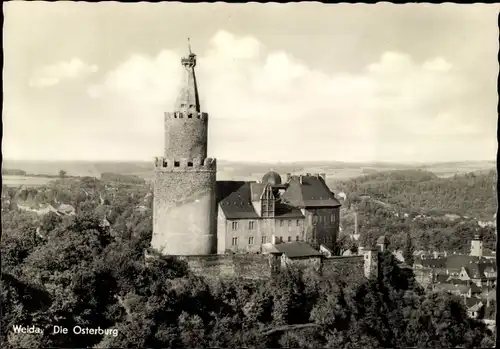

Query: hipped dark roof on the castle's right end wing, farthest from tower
left=281, top=176, right=340, bottom=207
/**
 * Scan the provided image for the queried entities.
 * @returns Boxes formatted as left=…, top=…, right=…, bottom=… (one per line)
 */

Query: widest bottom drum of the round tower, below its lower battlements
left=151, top=168, right=217, bottom=255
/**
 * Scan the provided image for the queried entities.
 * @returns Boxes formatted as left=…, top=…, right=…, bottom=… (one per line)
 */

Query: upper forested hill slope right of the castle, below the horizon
left=334, top=170, right=497, bottom=220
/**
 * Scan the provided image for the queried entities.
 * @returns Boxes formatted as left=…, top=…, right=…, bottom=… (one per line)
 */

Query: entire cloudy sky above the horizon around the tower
left=2, top=2, right=500, bottom=162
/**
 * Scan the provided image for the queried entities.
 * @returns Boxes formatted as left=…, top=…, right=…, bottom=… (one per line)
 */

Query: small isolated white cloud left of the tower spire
left=29, top=58, right=98, bottom=87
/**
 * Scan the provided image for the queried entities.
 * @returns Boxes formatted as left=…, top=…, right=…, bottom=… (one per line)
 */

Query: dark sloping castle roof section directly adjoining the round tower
left=216, top=181, right=259, bottom=219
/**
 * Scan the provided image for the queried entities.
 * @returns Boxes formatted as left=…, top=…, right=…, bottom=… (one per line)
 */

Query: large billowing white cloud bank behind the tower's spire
left=89, top=31, right=488, bottom=160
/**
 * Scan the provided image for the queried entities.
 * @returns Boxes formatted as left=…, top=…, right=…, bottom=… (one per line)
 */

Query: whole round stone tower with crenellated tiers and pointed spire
left=151, top=40, right=217, bottom=255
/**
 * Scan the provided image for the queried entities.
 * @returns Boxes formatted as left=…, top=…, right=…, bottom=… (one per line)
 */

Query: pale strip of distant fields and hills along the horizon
left=2, top=160, right=496, bottom=180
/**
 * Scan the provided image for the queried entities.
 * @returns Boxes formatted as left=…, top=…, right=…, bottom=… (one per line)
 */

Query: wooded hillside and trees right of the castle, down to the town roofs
left=335, top=171, right=496, bottom=253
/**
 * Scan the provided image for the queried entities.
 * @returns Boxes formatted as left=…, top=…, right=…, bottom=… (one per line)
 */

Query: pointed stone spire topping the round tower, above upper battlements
left=175, top=38, right=200, bottom=113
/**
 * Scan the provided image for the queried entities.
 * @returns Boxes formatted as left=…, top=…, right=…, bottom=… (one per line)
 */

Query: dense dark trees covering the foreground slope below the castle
left=0, top=178, right=493, bottom=348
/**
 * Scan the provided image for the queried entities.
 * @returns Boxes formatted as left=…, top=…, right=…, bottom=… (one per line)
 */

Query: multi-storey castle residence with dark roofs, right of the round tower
left=217, top=171, right=340, bottom=253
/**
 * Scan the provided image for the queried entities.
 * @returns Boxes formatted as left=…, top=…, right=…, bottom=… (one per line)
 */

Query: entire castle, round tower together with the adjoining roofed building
left=151, top=42, right=340, bottom=256
